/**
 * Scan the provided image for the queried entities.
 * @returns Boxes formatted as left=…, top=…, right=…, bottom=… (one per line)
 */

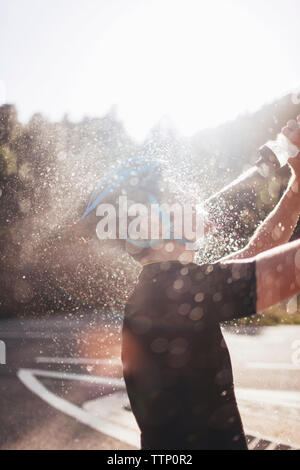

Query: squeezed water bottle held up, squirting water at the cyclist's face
left=259, top=134, right=299, bottom=167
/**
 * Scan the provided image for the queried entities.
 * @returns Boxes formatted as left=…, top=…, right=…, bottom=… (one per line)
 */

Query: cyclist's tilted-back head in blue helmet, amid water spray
left=81, top=159, right=211, bottom=264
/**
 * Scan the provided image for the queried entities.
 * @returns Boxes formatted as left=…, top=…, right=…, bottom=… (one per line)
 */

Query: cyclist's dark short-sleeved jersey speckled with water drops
left=122, top=262, right=256, bottom=450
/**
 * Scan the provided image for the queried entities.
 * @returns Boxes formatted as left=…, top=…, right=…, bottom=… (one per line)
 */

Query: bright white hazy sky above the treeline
left=0, top=0, right=300, bottom=139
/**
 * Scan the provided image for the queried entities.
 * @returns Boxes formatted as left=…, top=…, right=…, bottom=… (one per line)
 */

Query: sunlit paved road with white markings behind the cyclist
left=0, top=314, right=300, bottom=450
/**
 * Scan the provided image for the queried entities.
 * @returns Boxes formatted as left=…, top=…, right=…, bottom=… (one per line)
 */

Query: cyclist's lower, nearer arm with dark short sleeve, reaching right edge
left=217, top=240, right=300, bottom=321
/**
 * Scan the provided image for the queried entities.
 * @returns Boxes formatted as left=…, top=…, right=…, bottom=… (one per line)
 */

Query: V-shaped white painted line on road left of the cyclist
left=18, top=369, right=139, bottom=447
